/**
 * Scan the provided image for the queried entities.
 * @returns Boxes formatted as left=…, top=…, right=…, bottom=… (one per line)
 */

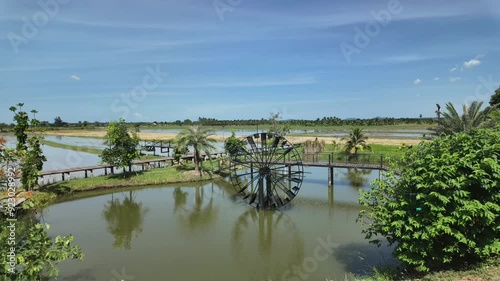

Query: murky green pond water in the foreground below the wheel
left=42, top=168, right=393, bottom=281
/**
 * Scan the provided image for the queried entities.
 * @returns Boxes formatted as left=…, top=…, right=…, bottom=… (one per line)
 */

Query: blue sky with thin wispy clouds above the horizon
left=0, top=0, right=500, bottom=123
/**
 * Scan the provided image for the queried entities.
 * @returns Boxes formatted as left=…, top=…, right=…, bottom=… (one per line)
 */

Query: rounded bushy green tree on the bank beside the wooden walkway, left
left=100, top=119, right=140, bottom=172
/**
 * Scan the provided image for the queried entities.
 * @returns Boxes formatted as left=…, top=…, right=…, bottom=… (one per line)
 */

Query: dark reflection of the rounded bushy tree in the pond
left=102, top=191, right=149, bottom=250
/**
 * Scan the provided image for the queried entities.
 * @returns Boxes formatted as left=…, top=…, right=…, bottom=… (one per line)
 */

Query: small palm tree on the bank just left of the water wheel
left=175, top=126, right=216, bottom=176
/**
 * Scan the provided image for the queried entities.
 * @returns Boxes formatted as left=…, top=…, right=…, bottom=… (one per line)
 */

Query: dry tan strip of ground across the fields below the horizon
left=45, top=130, right=421, bottom=145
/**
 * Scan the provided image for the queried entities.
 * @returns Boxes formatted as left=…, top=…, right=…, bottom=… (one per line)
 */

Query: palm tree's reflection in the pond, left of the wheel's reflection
left=172, top=183, right=218, bottom=234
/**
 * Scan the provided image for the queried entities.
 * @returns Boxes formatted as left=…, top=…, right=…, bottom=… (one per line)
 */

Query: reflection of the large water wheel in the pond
left=231, top=208, right=304, bottom=280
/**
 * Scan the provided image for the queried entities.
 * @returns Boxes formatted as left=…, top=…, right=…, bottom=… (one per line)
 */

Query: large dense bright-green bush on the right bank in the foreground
left=359, top=129, right=500, bottom=271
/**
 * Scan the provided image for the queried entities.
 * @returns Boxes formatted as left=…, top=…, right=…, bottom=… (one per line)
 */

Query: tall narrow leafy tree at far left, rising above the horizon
left=10, top=103, right=47, bottom=190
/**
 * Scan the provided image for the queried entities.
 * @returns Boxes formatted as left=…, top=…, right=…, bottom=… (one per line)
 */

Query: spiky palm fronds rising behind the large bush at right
left=431, top=101, right=491, bottom=135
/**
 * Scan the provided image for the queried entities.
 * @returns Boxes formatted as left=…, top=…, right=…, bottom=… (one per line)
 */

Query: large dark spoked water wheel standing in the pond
left=230, top=133, right=304, bottom=209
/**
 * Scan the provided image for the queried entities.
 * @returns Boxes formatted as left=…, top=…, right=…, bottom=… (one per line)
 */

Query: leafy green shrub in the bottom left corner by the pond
left=0, top=219, right=83, bottom=281
